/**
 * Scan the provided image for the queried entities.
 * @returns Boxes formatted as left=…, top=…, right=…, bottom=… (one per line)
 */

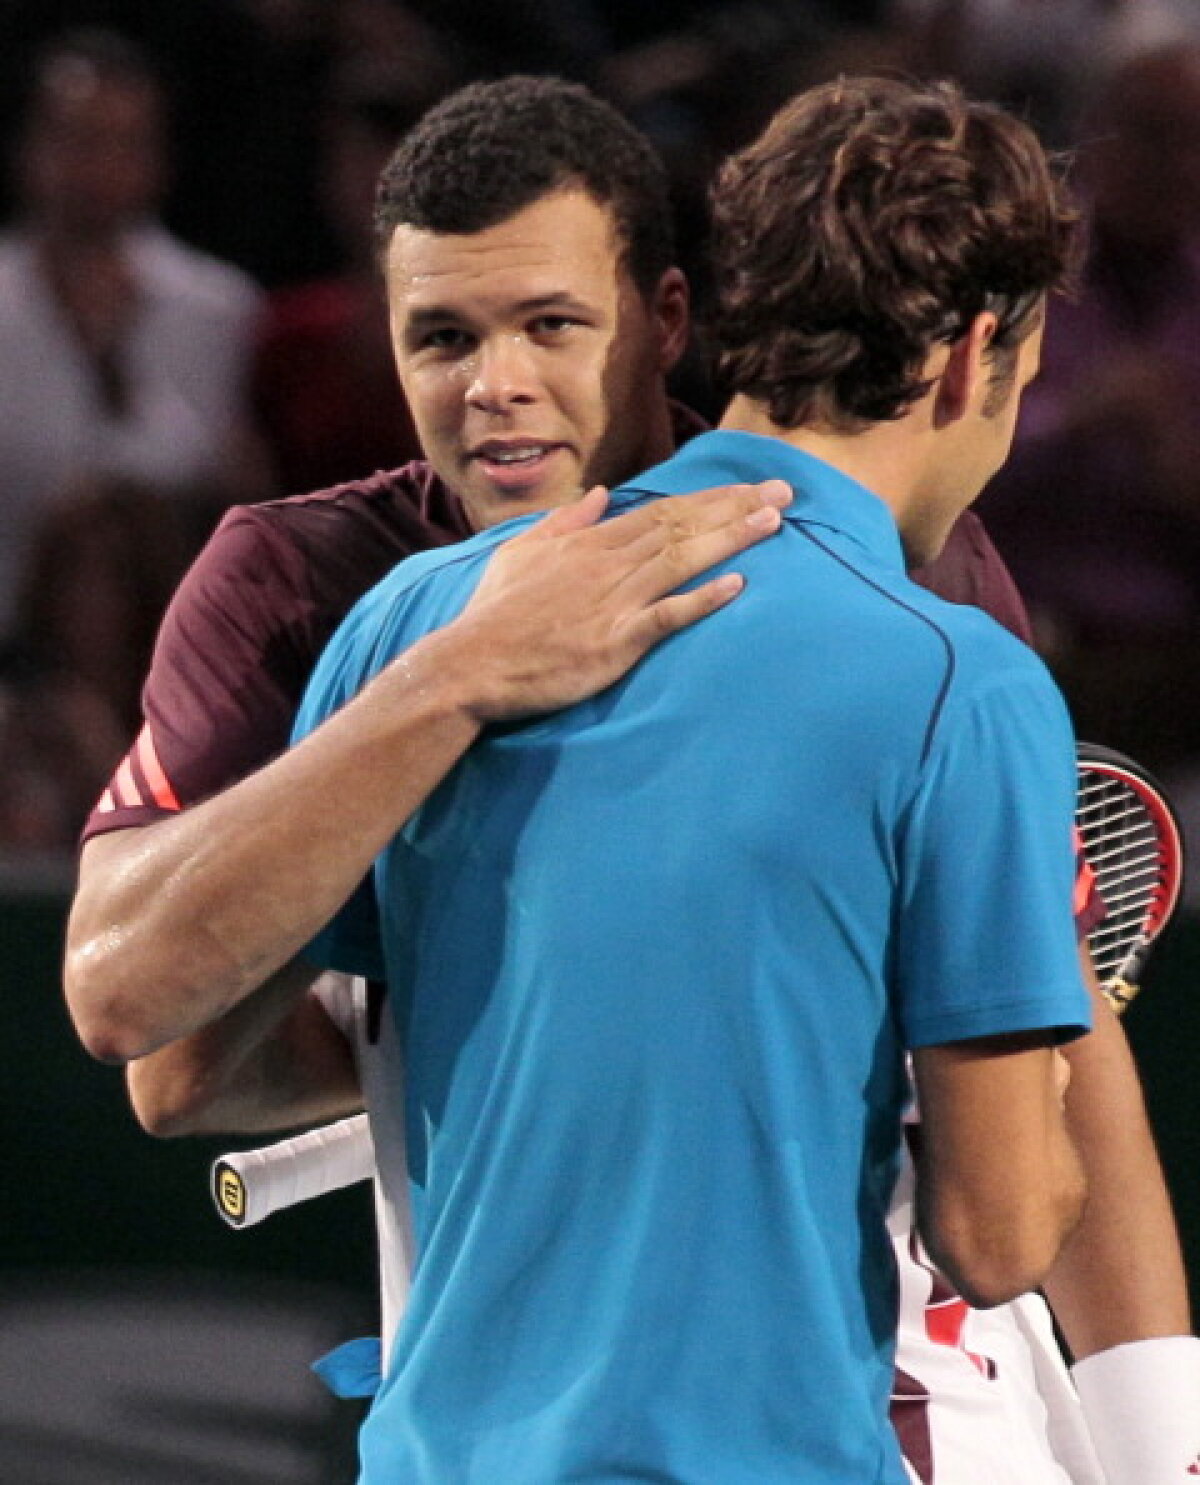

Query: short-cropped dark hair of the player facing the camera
left=374, top=76, right=674, bottom=294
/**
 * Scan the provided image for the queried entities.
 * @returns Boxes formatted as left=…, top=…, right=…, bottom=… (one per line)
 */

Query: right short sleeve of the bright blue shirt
left=894, top=668, right=1090, bottom=1047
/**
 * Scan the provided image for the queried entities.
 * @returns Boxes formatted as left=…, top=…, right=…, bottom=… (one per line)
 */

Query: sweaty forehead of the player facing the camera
left=385, top=190, right=625, bottom=315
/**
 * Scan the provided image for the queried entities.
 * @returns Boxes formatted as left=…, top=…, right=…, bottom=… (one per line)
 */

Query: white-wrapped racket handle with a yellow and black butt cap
left=212, top=1114, right=376, bottom=1227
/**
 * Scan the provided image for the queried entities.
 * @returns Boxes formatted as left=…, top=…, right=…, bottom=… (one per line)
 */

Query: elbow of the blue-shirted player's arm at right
left=922, top=1172, right=1086, bottom=1310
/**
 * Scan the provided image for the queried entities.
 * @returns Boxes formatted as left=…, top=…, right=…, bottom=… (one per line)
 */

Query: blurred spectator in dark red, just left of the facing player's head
left=252, top=48, right=451, bottom=493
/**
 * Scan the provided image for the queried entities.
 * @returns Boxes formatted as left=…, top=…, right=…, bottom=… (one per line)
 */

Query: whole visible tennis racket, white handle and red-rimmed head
left=212, top=743, right=1184, bottom=1227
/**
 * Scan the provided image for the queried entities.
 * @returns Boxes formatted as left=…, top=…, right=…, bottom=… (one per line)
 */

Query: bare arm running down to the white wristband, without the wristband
left=1046, top=950, right=1191, bottom=1359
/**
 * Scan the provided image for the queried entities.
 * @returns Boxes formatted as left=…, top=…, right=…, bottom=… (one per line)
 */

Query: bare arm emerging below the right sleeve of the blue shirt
left=913, top=1034, right=1086, bottom=1308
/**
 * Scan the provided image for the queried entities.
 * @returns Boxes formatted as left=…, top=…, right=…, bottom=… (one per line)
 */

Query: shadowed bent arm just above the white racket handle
left=125, top=964, right=362, bottom=1138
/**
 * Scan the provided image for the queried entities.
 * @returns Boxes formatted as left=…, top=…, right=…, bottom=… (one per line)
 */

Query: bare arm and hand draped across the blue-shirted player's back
left=64, top=481, right=790, bottom=1062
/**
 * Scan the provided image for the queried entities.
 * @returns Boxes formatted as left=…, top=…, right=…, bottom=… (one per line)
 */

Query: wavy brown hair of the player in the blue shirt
left=711, top=77, right=1080, bottom=431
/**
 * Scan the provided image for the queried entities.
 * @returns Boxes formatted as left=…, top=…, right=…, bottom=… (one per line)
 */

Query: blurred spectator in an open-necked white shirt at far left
left=0, top=31, right=267, bottom=630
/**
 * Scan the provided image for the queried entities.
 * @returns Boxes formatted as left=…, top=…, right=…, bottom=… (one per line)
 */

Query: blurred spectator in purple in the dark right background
left=980, top=42, right=1200, bottom=768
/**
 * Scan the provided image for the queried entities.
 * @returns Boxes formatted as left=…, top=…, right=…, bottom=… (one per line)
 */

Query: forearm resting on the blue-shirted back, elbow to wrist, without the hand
left=64, top=630, right=478, bottom=1062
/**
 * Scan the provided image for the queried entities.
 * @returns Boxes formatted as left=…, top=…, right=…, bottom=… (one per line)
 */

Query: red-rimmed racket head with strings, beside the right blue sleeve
left=1075, top=743, right=1184, bottom=1013
